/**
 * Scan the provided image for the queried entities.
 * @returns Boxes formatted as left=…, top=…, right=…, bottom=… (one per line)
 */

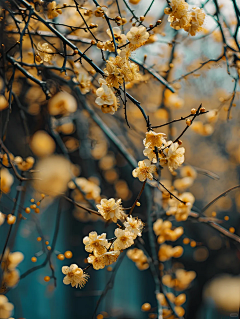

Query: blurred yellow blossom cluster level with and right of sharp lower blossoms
left=153, top=218, right=183, bottom=244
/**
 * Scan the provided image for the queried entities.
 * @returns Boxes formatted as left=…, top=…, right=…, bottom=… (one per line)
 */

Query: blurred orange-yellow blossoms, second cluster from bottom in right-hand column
left=162, top=269, right=196, bottom=291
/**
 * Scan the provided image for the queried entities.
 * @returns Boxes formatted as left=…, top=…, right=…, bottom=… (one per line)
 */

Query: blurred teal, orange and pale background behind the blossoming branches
left=0, top=0, right=240, bottom=319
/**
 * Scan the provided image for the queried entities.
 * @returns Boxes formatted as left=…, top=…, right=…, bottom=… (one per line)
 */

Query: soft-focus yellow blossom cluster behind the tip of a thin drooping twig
left=166, top=192, right=195, bottom=221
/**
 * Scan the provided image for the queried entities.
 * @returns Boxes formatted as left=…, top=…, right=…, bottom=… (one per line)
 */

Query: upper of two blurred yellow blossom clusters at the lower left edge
left=2, top=249, right=24, bottom=288
